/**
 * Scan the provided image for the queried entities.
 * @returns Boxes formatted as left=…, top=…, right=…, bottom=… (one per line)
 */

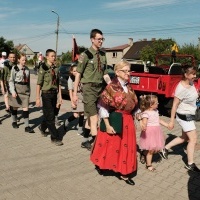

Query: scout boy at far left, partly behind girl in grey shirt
left=3, top=52, right=16, bottom=113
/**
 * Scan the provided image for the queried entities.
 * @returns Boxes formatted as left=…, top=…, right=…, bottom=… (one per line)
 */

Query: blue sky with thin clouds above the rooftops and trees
left=0, top=0, right=200, bottom=54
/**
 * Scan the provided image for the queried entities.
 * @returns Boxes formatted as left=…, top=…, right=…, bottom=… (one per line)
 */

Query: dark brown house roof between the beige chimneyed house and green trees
left=123, top=40, right=154, bottom=59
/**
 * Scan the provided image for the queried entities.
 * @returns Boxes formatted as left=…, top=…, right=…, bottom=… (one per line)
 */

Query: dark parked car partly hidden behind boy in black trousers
left=59, top=63, right=75, bottom=95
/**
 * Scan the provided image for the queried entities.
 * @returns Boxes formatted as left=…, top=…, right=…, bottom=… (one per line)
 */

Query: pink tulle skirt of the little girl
left=139, top=126, right=165, bottom=151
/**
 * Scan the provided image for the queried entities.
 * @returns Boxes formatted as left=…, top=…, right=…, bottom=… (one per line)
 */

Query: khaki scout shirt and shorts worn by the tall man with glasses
left=77, top=47, right=107, bottom=116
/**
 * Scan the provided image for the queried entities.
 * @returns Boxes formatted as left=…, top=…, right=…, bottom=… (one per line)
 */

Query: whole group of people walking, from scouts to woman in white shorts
left=0, top=29, right=200, bottom=189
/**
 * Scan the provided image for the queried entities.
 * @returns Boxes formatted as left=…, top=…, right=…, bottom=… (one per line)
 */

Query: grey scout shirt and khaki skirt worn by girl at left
left=8, top=65, right=30, bottom=108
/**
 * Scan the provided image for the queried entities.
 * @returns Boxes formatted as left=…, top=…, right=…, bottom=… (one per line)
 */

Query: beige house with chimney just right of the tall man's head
left=102, top=38, right=133, bottom=66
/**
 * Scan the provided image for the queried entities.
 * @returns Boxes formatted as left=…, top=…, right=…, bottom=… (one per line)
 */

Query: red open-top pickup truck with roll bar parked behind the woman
left=130, top=54, right=200, bottom=113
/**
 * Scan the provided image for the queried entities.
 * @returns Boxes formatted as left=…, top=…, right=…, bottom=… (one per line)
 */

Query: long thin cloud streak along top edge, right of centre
left=104, top=0, right=179, bottom=10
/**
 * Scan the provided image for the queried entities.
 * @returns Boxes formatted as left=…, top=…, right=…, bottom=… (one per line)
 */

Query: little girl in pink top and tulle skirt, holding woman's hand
left=140, top=95, right=168, bottom=171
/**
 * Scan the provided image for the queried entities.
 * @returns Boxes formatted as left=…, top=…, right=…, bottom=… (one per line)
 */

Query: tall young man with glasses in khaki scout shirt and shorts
left=73, top=29, right=110, bottom=150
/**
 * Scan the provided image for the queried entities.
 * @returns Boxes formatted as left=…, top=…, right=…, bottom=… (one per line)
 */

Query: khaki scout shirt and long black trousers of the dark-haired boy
left=37, top=63, right=61, bottom=141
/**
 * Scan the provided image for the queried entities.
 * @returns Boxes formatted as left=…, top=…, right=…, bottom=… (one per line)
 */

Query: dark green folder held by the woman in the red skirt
left=100, top=112, right=123, bottom=134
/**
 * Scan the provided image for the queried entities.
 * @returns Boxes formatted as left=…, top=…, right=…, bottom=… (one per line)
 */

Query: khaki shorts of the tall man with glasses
left=83, top=83, right=102, bottom=117
